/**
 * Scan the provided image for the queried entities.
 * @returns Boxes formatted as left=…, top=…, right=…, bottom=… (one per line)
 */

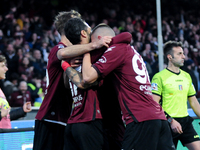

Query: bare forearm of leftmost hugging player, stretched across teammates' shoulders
left=57, top=36, right=112, bottom=60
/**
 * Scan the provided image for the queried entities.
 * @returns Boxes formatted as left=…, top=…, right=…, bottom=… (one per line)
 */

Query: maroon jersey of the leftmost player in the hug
left=36, top=42, right=72, bottom=125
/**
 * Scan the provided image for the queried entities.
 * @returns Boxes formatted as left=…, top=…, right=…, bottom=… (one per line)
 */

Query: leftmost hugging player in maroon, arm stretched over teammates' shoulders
left=33, top=10, right=111, bottom=150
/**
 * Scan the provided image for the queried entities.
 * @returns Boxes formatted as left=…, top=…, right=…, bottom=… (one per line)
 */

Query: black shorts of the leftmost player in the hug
left=33, top=120, right=66, bottom=150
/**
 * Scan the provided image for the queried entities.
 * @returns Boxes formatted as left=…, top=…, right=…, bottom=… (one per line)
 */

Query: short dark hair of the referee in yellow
left=163, top=41, right=183, bottom=63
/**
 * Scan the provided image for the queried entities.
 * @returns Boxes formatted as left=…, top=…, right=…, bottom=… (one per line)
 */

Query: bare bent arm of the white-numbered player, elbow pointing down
left=82, top=53, right=99, bottom=84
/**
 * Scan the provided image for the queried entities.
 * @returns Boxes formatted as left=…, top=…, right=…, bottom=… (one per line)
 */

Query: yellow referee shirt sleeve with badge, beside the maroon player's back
left=151, top=74, right=162, bottom=96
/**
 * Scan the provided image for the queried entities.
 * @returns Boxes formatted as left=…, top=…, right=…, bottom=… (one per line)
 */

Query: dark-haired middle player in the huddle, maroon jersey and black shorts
left=62, top=18, right=103, bottom=150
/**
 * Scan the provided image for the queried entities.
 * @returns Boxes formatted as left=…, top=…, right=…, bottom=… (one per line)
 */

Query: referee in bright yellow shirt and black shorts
left=152, top=41, right=200, bottom=150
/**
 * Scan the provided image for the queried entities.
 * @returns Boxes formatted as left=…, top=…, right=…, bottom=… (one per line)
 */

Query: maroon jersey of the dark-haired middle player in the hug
left=67, top=66, right=102, bottom=124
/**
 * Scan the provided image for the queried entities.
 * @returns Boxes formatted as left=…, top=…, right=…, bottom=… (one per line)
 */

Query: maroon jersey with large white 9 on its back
left=93, top=32, right=166, bottom=124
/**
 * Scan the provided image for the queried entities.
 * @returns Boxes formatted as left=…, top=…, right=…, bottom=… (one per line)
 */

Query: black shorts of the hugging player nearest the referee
left=122, top=120, right=175, bottom=150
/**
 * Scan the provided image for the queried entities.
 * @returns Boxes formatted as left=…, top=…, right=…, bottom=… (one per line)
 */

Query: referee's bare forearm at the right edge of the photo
left=188, top=96, right=200, bottom=118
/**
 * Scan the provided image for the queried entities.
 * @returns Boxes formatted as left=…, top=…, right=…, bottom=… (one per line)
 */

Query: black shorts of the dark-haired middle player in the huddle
left=64, top=120, right=103, bottom=150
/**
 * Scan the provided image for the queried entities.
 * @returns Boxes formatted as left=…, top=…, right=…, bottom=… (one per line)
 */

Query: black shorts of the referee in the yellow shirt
left=172, top=116, right=200, bottom=146
